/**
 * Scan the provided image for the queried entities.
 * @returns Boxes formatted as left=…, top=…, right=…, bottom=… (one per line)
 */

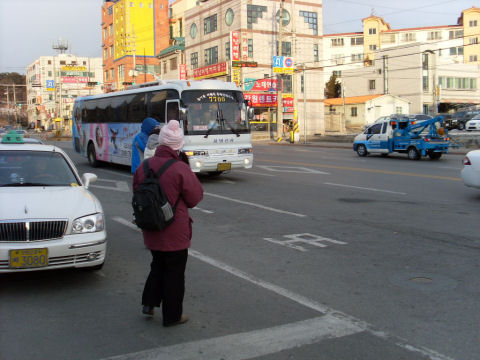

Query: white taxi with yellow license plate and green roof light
left=0, top=134, right=107, bottom=273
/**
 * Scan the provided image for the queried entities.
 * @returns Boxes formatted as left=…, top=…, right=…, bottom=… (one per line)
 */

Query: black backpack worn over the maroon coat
left=132, top=159, right=180, bottom=230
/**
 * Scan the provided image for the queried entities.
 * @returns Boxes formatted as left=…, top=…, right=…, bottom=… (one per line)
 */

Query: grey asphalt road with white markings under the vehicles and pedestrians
left=0, top=143, right=480, bottom=360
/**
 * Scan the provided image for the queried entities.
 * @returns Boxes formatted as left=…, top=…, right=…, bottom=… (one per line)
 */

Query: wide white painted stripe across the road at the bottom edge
left=102, top=316, right=362, bottom=360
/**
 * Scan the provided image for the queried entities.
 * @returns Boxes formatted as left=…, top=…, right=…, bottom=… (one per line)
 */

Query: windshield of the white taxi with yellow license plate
left=0, top=150, right=80, bottom=187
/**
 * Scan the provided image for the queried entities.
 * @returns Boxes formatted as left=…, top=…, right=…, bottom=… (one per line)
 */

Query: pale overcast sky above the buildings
left=0, top=0, right=480, bottom=74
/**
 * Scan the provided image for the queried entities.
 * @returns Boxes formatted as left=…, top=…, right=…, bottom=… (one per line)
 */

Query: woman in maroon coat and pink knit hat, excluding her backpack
left=133, top=120, right=203, bottom=326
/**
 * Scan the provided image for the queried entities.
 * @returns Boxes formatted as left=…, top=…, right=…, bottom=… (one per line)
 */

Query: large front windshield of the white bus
left=182, top=90, right=250, bottom=136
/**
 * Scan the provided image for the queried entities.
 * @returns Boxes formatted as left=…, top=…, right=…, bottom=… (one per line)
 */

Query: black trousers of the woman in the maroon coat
left=142, top=249, right=188, bottom=324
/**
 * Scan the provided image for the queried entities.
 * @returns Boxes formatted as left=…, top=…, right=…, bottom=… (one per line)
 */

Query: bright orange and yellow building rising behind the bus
left=102, top=0, right=170, bottom=92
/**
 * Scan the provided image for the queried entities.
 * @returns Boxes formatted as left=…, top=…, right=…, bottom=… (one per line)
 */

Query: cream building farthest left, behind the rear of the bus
left=26, top=54, right=103, bottom=130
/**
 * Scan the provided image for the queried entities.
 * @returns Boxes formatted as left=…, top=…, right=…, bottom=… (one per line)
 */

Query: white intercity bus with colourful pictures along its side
left=72, top=80, right=253, bottom=174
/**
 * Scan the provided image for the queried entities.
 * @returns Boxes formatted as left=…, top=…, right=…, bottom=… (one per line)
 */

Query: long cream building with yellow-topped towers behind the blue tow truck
left=323, top=7, right=480, bottom=112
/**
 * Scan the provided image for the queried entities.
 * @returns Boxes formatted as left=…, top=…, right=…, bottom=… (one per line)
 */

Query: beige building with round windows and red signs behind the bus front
left=184, top=0, right=324, bottom=134
